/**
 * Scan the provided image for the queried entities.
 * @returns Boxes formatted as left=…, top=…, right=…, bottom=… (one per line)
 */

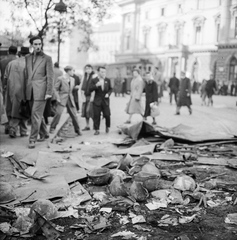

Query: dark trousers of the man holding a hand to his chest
left=93, top=102, right=110, bottom=130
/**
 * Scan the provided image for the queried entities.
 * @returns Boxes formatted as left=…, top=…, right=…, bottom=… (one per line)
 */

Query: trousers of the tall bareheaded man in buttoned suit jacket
left=29, top=100, right=48, bottom=142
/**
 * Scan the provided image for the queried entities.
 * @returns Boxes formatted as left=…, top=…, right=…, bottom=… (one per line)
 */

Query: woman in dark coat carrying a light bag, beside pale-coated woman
left=144, top=72, right=158, bottom=125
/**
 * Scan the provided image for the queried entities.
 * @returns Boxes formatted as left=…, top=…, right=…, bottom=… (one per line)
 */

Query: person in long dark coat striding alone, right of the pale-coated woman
left=176, top=72, right=192, bottom=115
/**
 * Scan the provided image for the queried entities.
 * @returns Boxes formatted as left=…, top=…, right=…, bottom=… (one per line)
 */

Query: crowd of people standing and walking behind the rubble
left=0, top=36, right=230, bottom=148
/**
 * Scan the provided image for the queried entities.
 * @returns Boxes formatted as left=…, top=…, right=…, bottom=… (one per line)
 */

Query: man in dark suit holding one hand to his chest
left=90, top=67, right=112, bottom=135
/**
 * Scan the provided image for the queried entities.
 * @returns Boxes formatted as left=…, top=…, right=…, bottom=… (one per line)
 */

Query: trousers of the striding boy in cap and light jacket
left=50, top=100, right=80, bottom=132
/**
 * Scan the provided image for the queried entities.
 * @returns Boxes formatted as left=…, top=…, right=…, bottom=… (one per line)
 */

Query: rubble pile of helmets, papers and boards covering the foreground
left=0, top=122, right=237, bottom=240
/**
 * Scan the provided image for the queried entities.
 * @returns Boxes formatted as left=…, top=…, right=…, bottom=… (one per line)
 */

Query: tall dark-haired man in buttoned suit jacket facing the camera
left=26, top=36, right=54, bottom=148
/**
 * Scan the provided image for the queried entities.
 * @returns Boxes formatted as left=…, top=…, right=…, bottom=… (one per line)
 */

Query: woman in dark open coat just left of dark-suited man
left=81, top=64, right=95, bottom=131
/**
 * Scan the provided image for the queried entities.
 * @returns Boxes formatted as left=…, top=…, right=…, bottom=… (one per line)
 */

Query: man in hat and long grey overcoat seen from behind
left=4, top=47, right=29, bottom=138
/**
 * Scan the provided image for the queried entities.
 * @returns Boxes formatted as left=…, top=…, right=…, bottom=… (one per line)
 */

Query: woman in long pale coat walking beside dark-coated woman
left=125, top=68, right=144, bottom=124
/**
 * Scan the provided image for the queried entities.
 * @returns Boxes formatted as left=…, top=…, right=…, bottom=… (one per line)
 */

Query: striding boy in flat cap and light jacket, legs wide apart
left=50, top=66, right=81, bottom=136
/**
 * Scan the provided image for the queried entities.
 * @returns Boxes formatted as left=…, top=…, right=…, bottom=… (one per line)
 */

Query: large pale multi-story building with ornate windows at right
left=113, top=0, right=237, bottom=85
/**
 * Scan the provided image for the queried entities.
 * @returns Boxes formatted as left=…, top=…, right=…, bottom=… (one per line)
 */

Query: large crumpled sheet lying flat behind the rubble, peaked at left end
left=122, top=121, right=237, bottom=143
